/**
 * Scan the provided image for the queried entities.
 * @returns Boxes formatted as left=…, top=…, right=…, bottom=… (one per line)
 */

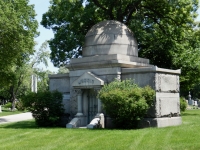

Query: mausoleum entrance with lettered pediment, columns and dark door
left=67, top=72, right=104, bottom=128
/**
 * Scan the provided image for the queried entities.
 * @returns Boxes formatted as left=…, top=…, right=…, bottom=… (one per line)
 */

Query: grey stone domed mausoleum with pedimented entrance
left=49, top=20, right=182, bottom=128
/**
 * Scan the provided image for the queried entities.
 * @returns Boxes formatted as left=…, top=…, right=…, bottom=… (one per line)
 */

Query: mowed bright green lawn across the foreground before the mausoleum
left=0, top=110, right=200, bottom=150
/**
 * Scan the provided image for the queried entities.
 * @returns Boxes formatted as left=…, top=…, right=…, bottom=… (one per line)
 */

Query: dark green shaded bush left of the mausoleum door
left=22, top=91, right=64, bottom=126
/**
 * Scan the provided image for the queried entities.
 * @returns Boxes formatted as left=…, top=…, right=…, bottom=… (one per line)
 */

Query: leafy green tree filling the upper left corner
left=0, top=0, right=38, bottom=86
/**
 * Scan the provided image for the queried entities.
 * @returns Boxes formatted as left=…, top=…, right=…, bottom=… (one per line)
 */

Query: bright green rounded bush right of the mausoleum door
left=98, top=80, right=155, bottom=128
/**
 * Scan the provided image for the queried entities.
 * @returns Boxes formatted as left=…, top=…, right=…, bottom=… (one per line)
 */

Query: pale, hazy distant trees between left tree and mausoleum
left=0, top=42, right=51, bottom=110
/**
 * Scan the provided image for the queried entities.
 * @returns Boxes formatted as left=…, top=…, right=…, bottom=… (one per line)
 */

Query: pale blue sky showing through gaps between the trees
left=29, top=0, right=200, bottom=72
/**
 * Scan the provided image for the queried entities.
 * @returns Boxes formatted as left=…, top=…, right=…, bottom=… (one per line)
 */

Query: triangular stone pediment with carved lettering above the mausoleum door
left=72, top=72, right=104, bottom=88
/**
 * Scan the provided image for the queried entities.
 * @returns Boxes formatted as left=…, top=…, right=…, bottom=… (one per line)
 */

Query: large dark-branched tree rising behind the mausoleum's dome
left=41, top=0, right=200, bottom=95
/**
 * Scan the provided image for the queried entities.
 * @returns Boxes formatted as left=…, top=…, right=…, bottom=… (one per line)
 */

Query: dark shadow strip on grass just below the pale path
left=0, top=120, right=39, bottom=129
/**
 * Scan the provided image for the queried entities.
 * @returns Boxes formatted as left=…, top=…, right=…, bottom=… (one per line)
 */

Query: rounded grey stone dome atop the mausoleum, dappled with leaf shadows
left=83, top=20, right=138, bottom=57
